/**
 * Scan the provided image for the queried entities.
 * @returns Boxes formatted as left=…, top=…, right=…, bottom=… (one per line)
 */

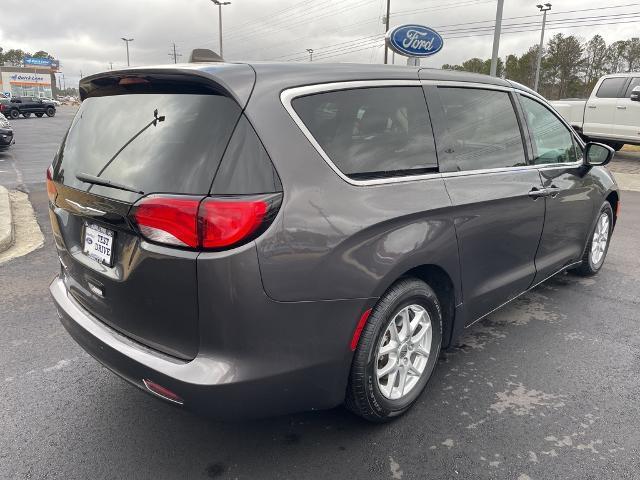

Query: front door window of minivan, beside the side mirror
left=520, top=95, right=580, bottom=165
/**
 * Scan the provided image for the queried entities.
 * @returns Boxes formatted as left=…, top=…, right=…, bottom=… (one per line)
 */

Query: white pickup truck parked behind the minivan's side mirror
left=551, top=73, right=640, bottom=150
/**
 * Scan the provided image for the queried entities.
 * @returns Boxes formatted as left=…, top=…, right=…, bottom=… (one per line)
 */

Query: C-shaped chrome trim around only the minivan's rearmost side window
left=280, top=80, right=442, bottom=186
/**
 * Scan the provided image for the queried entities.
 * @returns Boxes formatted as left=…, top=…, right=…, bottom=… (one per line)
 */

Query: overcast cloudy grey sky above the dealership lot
left=0, top=0, right=640, bottom=85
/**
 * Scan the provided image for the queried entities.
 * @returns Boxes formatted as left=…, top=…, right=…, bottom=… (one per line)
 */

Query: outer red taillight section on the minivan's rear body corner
left=200, top=199, right=269, bottom=248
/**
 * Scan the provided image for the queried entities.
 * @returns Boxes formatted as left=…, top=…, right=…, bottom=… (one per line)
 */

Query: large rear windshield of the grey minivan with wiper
left=54, top=93, right=241, bottom=201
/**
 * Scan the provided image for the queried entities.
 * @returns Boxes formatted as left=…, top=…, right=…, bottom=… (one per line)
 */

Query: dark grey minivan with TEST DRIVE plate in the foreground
left=47, top=63, right=619, bottom=421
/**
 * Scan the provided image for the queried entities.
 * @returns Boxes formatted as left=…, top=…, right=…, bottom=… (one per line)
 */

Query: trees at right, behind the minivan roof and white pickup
left=442, top=33, right=640, bottom=100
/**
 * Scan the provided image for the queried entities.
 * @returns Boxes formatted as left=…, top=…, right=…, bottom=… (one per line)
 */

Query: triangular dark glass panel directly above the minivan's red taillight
left=211, top=115, right=282, bottom=195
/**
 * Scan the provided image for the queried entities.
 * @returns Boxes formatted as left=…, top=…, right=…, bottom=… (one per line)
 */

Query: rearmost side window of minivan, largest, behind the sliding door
left=292, top=87, right=438, bottom=180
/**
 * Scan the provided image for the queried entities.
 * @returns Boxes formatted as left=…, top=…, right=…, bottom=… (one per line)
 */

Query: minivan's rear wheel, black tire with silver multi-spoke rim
left=345, top=278, right=442, bottom=422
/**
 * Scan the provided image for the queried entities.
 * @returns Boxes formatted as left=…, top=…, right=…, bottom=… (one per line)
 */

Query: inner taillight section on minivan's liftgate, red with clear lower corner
left=133, top=197, right=201, bottom=248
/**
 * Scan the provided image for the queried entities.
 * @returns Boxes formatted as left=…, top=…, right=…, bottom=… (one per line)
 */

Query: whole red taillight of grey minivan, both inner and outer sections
left=133, top=194, right=281, bottom=250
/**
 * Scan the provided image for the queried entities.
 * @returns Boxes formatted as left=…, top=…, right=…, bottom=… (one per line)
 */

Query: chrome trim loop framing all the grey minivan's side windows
left=280, top=80, right=584, bottom=186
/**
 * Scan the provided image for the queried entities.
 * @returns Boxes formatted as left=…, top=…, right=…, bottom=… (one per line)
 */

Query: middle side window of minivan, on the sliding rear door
left=437, top=87, right=527, bottom=171
